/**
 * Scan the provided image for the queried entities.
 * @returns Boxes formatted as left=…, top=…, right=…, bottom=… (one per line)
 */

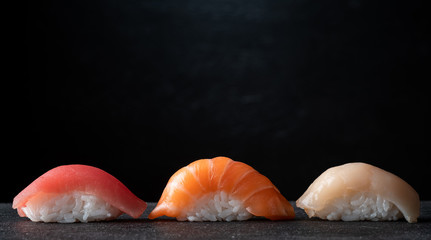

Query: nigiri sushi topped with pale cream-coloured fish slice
left=296, top=162, right=420, bottom=223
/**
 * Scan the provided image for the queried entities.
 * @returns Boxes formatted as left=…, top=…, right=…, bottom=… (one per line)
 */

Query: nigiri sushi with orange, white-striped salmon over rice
left=148, top=157, right=295, bottom=221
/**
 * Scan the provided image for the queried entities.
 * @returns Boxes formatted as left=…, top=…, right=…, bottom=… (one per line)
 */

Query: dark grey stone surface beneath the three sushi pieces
left=0, top=201, right=431, bottom=239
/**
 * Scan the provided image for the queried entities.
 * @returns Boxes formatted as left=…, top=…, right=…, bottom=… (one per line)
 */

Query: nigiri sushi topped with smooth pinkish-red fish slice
left=12, top=164, right=147, bottom=223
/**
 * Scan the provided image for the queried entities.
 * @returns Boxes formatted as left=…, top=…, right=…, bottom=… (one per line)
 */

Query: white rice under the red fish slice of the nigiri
left=22, top=191, right=122, bottom=223
